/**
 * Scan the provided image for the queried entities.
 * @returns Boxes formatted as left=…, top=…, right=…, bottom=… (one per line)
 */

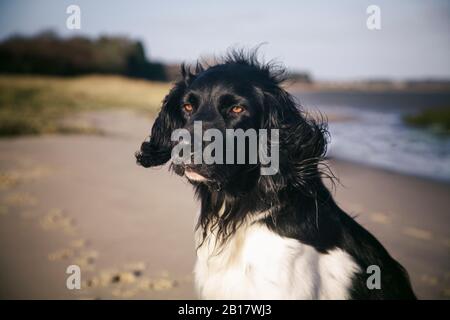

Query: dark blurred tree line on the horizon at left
left=0, top=31, right=167, bottom=81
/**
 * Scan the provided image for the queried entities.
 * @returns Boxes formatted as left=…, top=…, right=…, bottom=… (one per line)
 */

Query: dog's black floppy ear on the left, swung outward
left=135, top=80, right=186, bottom=168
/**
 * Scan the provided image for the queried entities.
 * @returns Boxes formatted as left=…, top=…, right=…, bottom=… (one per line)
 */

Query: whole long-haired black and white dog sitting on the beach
left=136, top=51, right=415, bottom=299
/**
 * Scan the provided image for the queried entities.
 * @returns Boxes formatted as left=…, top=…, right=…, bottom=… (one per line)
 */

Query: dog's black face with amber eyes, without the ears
left=173, top=65, right=264, bottom=188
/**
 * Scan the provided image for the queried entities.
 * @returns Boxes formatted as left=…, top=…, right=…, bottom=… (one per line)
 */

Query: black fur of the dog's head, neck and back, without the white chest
left=136, top=51, right=415, bottom=299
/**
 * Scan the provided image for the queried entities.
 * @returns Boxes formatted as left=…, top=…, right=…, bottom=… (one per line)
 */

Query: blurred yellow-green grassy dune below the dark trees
left=0, top=75, right=169, bottom=136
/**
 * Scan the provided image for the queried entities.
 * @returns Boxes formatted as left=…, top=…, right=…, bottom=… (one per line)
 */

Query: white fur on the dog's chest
left=195, top=219, right=359, bottom=299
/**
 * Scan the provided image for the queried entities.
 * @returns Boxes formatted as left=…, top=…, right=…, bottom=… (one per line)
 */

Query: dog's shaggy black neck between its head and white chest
left=196, top=169, right=336, bottom=249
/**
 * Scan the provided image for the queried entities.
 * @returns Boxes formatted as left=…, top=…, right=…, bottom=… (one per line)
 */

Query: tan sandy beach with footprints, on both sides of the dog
left=0, top=111, right=450, bottom=299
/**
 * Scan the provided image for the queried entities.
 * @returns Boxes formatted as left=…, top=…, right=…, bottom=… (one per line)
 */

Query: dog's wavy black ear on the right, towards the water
left=261, top=88, right=328, bottom=195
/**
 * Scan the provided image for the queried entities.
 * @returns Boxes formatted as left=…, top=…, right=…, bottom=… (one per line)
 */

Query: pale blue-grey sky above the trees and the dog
left=0, top=0, right=450, bottom=80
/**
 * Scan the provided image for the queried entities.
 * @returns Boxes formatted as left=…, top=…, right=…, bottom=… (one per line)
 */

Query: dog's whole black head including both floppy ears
left=136, top=51, right=326, bottom=199
